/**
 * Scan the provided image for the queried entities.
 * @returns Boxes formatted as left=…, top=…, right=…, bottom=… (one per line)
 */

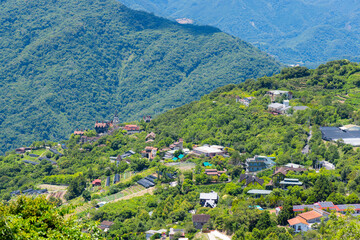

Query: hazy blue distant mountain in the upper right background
left=120, top=0, right=360, bottom=67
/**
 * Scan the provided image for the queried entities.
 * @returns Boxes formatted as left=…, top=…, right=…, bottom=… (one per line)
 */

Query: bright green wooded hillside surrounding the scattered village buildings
left=0, top=60, right=360, bottom=240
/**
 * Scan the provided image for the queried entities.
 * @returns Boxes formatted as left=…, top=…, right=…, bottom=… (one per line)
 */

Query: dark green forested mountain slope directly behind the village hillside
left=0, top=0, right=279, bottom=152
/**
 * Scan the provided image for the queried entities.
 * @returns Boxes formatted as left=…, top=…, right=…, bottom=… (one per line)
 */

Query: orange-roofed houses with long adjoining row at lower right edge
left=288, top=202, right=360, bottom=232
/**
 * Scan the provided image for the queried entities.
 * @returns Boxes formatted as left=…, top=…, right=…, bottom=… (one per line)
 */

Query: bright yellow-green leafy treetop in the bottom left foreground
left=0, top=196, right=101, bottom=240
